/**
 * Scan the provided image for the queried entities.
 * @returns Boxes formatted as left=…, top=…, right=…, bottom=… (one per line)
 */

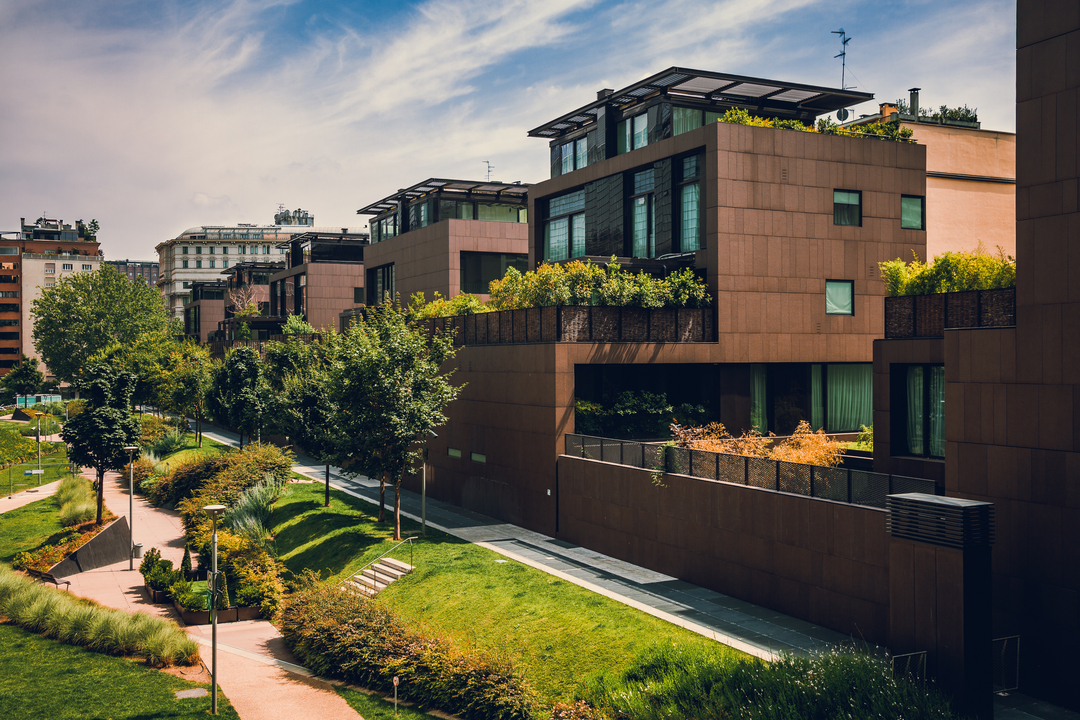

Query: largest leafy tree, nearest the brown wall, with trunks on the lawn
left=329, top=303, right=460, bottom=540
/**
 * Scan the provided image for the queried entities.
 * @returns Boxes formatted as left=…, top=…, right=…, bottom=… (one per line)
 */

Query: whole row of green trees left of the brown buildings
left=32, top=266, right=459, bottom=538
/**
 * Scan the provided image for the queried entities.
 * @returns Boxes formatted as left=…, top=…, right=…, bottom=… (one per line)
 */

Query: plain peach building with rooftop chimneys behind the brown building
left=847, top=87, right=1016, bottom=261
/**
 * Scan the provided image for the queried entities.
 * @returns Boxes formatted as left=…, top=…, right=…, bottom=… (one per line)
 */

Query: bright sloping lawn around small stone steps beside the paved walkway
left=271, top=484, right=744, bottom=704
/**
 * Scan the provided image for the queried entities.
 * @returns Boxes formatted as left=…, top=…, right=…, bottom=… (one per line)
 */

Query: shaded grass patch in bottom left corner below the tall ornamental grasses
left=0, top=625, right=240, bottom=720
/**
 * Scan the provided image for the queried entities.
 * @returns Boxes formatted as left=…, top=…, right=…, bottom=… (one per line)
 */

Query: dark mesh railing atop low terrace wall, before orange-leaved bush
left=565, top=434, right=937, bottom=508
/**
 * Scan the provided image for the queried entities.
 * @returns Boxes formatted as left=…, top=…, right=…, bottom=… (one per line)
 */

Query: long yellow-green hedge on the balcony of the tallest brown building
left=489, top=258, right=712, bottom=310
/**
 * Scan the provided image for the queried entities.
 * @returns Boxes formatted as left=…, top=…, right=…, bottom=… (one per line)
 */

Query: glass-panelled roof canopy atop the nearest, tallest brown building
left=528, top=67, right=874, bottom=139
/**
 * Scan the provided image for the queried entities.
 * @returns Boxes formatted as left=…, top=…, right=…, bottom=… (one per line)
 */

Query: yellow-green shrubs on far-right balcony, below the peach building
left=879, top=243, right=1016, bottom=297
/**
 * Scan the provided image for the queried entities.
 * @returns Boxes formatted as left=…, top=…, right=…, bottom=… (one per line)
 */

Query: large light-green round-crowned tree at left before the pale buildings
left=30, top=263, right=173, bottom=382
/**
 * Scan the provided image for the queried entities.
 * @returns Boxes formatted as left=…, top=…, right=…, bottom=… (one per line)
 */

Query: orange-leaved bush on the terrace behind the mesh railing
left=671, top=420, right=843, bottom=467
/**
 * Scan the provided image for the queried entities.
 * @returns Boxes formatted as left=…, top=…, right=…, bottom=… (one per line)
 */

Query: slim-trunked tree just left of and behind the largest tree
left=267, top=336, right=340, bottom=507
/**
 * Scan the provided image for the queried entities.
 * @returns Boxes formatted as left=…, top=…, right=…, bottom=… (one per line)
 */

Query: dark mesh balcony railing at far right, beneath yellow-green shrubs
left=885, top=287, right=1016, bottom=340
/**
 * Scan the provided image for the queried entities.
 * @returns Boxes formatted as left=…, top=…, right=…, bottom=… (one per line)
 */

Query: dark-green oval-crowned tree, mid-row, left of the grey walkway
left=206, top=345, right=268, bottom=447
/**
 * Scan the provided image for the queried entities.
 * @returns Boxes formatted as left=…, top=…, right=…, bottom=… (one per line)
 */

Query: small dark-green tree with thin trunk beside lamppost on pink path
left=60, top=363, right=139, bottom=525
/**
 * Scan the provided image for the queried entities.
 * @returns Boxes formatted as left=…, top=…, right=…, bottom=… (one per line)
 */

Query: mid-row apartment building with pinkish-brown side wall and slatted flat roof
left=356, top=178, right=529, bottom=304
